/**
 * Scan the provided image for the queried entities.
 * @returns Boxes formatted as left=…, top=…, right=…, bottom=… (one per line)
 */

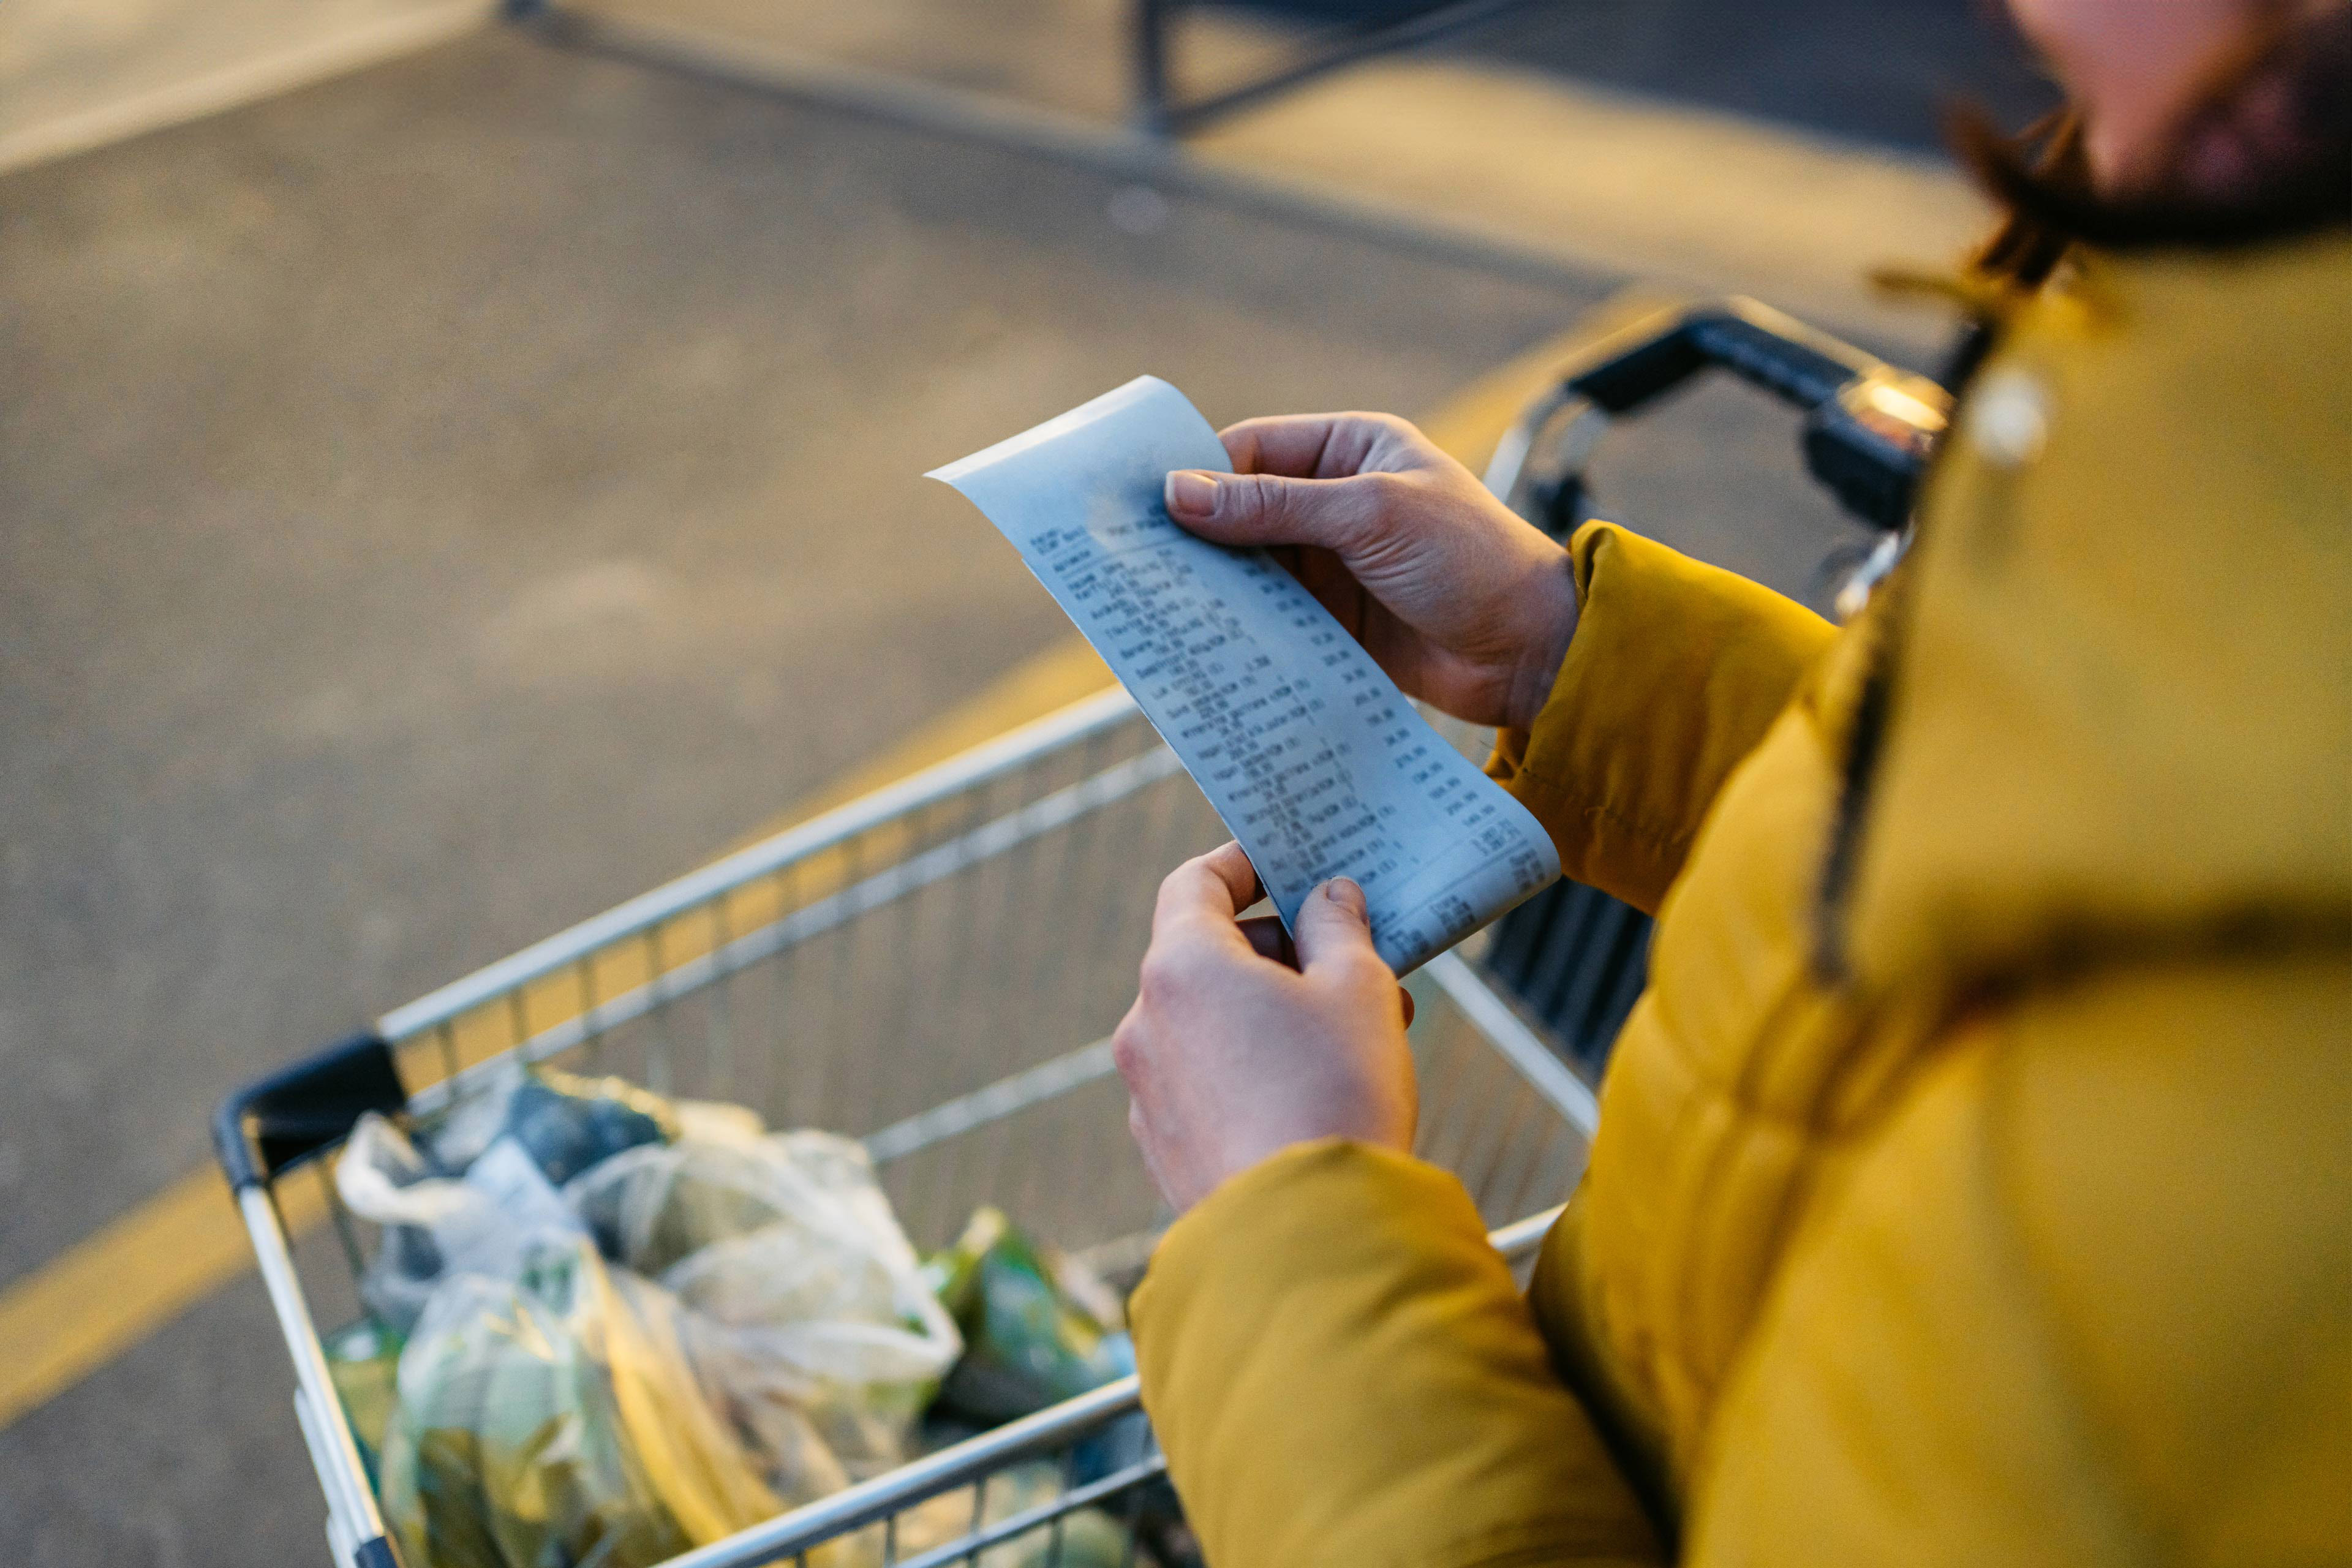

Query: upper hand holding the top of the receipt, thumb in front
left=1167, top=414, right=1576, bottom=729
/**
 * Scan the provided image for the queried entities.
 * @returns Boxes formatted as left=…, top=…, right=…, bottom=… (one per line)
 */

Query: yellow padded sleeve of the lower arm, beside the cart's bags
left=1134, top=1142, right=1660, bottom=1568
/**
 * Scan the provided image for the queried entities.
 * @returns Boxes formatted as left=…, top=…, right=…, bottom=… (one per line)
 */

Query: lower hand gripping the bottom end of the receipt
left=1110, top=844, right=1416, bottom=1213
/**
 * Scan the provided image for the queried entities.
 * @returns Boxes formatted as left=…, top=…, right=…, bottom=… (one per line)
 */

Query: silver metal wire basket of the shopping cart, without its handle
left=216, top=691, right=1595, bottom=1568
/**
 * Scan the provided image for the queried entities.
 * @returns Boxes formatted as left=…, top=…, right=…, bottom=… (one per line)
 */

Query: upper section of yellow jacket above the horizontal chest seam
left=1828, top=238, right=2352, bottom=995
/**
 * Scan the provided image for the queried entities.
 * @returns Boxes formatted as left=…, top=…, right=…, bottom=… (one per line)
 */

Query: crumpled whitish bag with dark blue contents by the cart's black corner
left=334, top=1067, right=680, bottom=1333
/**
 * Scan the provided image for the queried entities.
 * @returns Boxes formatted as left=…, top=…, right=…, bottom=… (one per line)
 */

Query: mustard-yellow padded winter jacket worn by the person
left=1134, top=238, right=2352, bottom=1568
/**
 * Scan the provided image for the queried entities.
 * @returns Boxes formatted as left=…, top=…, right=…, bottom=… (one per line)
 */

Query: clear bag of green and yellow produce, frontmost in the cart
left=381, top=1237, right=781, bottom=1568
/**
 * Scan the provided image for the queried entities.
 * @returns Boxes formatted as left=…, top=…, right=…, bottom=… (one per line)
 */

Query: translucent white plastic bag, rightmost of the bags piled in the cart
left=565, top=1133, right=962, bottom=1498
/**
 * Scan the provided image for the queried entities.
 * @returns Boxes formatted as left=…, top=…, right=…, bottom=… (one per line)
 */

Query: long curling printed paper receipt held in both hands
left=932, top=376, right=1559, bottom=973
